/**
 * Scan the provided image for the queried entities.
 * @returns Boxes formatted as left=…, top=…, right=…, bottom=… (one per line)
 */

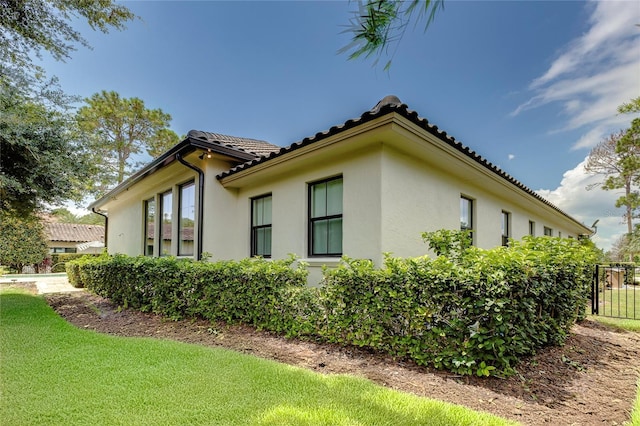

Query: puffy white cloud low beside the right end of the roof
left=536, top=158, right=626, bottom=251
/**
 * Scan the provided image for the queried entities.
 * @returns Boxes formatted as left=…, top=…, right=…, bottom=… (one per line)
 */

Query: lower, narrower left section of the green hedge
left=67, top=255, right=307, bottom=331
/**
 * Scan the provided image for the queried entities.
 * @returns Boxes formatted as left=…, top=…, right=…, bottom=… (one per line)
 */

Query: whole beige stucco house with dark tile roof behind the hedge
left=90, top=96, right=592, bottom=282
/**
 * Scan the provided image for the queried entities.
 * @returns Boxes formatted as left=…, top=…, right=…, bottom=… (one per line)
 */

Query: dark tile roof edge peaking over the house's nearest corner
left=216, top=95, right=587, bottom=233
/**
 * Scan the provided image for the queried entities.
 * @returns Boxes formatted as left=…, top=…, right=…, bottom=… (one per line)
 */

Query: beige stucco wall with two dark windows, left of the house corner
left=224, top=145, right=381, bottom=283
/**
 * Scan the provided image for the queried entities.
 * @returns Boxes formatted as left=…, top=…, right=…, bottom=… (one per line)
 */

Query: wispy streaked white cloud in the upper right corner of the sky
left=511, top=1, right=640, bottom=149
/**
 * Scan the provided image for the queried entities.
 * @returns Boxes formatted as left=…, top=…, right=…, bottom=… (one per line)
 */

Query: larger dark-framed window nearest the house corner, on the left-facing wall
left=309, top=177, right=342, bottom=256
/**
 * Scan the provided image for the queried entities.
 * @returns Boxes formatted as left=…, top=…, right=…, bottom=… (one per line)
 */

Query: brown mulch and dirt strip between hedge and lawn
left=46, top=292, right=640, bottom=425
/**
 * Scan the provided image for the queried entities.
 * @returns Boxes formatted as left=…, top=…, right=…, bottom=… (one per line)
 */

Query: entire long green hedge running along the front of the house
left=67, top=235, right=593, bottom=376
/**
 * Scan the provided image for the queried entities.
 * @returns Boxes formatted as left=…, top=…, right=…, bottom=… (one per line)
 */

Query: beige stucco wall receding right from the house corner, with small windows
left=382, top=135, right=579, bottom=257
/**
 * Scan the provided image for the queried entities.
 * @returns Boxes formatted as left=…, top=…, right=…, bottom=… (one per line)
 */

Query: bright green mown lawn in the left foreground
left=0, top=291, right=514, bottom=425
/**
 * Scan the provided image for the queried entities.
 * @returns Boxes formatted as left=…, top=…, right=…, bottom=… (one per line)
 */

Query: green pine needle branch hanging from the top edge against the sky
left=339, top=0, right=444, bottom=70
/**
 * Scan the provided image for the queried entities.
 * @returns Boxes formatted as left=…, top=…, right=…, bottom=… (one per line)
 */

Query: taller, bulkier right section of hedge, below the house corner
left=318, top=231, right=593, bottom=376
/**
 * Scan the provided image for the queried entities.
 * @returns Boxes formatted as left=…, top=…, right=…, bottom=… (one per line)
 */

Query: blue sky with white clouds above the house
left=44, top=0, right=640, bottom=249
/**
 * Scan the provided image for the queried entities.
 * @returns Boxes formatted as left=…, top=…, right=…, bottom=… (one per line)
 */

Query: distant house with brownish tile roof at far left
left=45, top=222, right=104, bottom=254
